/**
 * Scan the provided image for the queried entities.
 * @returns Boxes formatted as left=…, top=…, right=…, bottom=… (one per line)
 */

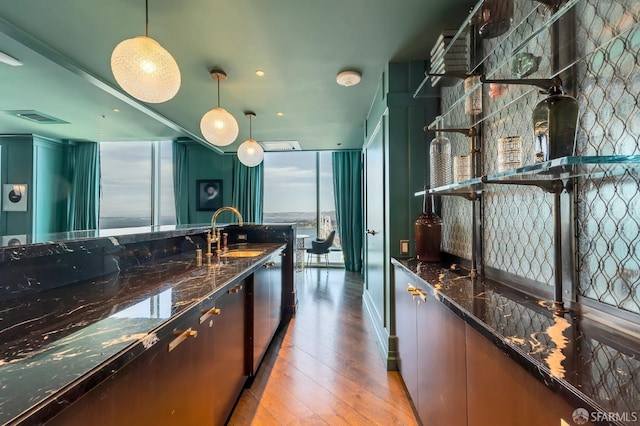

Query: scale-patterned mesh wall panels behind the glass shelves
left=441, top=0, right=640, bottom=313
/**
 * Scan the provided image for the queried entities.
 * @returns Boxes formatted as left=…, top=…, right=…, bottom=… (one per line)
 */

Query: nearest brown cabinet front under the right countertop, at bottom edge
left=467, top=325, right=580, bottom=426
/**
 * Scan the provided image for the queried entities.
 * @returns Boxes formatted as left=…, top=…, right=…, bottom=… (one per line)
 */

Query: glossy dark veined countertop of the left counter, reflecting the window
left=0, top=243, right=284, bottom=424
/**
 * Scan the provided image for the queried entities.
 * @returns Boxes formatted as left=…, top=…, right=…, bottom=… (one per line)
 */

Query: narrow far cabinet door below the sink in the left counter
left=249, top=260, right=271, bottom=374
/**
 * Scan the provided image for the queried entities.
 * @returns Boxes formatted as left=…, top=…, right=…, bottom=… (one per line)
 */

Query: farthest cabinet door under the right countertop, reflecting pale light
left=394, top=268, right=418, bottom=407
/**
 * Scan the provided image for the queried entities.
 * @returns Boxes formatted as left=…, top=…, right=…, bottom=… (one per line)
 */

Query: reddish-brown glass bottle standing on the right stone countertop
left=413, top=188, right=442, bottom=262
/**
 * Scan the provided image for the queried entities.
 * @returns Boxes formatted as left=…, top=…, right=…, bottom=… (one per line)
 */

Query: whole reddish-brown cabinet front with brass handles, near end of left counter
left=47, top=280, right=248, bottom=426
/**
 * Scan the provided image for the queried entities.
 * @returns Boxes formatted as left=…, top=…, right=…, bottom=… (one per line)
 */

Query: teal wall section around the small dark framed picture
left=182, top=142, right=233, bottom=223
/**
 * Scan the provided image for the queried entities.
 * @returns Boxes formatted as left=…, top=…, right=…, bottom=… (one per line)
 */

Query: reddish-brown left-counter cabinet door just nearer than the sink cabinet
left=210, top=281, right=248, bottom=425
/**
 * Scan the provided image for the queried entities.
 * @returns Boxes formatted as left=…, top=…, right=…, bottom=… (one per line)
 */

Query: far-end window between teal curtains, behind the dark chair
left=263, top=151, right=343, bottom=265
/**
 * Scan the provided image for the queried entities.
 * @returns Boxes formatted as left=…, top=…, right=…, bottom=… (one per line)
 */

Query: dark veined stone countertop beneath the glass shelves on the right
left=392, top=259, right=640, bottom=424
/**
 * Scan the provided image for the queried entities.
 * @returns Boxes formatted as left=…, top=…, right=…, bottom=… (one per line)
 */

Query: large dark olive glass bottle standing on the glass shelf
left=533, top=85, right=578, bottom=163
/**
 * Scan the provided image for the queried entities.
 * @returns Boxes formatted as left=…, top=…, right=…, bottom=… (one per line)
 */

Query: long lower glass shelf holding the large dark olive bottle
left=414, top=155, right=640, bottom=197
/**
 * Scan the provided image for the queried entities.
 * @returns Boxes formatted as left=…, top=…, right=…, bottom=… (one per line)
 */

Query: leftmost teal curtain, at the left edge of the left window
left=67, top=142, right=100, bottom=231
